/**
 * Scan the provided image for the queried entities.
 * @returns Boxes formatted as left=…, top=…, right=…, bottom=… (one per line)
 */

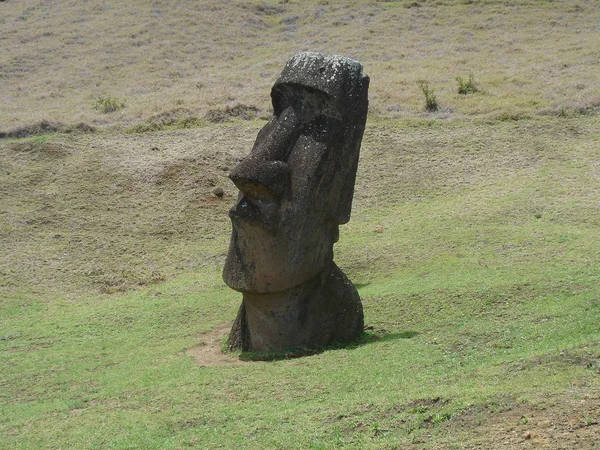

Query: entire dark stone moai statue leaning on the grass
left=223, top=53, right=369, bottom=351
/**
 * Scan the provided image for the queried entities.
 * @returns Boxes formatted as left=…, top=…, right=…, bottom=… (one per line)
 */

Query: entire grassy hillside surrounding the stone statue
left=0, top=0, right=600, bottom=450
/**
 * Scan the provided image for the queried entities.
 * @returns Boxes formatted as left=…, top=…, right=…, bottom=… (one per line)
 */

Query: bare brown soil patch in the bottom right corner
left=434, top=393, right=600, bottom=450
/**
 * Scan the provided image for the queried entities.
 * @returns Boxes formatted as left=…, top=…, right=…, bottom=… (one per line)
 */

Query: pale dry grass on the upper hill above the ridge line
left=0, top=0, right=600, bottom=131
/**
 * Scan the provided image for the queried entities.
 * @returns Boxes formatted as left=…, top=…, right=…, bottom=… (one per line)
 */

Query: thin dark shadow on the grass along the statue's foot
left=239, top=325, right=420, bottom=361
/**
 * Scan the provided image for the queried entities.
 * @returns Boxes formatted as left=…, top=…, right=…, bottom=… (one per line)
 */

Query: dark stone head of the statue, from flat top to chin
left=223, top=53, right=369, bottom=293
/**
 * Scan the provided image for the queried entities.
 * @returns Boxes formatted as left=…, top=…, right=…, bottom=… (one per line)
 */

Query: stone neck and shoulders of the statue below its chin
left=228, top=262, right=364, bottom=352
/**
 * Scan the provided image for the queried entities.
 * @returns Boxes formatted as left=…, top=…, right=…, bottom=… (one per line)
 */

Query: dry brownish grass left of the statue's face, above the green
left=0, top=122, right=257, bottom=293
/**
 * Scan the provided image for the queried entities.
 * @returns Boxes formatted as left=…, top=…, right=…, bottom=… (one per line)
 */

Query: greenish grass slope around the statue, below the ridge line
left=0, top=117, right=600, bottom=449
